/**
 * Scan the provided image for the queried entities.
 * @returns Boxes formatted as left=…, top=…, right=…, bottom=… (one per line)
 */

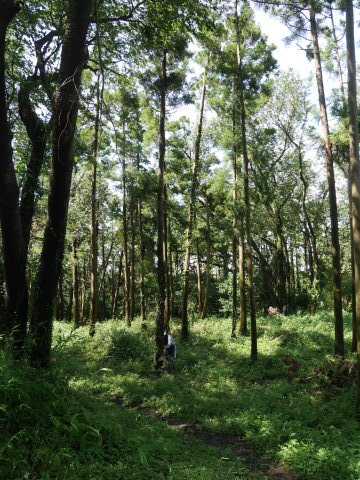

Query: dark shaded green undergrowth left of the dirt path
left=0, top=326, right=262, bottom=480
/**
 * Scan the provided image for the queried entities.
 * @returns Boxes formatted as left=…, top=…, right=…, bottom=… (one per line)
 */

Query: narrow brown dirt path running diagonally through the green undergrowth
left=112, top=397, right=306, bottom=480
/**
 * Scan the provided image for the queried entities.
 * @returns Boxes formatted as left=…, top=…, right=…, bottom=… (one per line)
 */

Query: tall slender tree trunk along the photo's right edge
left=345, top=0, right=360, bottom=420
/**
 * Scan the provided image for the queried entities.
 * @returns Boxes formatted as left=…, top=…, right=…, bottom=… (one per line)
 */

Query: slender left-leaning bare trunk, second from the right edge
left=309, top=3, right=344, bottom=356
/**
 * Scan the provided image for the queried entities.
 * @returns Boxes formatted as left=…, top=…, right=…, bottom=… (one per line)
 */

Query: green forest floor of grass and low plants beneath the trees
left=0, top=312, right=360, bottom=480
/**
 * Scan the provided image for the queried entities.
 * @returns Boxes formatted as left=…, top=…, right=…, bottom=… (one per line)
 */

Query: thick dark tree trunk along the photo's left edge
left=0, top=0, right=27, bottom=355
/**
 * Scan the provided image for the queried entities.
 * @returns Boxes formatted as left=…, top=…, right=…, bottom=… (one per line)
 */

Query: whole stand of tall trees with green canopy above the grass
left=0, top=0, right=360, bottom=408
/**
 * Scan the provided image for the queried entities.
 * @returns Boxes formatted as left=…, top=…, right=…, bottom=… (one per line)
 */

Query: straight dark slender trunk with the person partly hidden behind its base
left=154, top=49, right=167, bottom=369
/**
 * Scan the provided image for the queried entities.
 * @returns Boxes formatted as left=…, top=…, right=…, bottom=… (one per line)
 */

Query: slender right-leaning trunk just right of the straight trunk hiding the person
left=181, top=69, right=206, bottom=340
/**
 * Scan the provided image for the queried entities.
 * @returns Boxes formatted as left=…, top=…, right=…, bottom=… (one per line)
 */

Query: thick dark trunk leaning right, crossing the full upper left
left=30, top=0, right=92, bottom=367
